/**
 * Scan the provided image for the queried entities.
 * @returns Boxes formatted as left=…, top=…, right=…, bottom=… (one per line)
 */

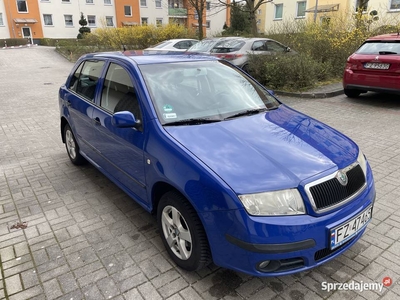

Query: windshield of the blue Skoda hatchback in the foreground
left=139, top=60, right=279, bottom=125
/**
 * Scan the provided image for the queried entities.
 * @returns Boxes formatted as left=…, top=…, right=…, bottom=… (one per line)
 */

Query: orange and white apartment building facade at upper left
left=0, top=0, right=229, bottom=39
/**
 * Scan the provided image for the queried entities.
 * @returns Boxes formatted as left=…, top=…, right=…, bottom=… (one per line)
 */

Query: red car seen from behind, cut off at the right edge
left=343, top=33, right=400, bottom=98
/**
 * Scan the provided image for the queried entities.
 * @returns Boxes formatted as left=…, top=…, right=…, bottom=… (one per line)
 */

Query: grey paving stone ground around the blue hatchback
left=0, top=46, right=400, bottom=300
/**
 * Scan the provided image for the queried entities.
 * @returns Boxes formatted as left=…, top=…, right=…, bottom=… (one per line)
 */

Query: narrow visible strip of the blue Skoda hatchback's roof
left=82, top=50, right=218, bottom=65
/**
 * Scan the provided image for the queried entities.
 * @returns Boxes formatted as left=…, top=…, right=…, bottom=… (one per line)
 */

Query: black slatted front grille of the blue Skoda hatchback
left=310, top=165, right=365, bottom=210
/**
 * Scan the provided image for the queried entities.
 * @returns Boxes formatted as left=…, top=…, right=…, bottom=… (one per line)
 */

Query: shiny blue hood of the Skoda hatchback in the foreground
left=164, top=105, right=358, bottom=194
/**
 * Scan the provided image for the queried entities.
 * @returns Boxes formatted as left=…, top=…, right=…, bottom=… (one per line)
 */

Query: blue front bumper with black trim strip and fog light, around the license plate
left=202, top=171, right=376, bottom=276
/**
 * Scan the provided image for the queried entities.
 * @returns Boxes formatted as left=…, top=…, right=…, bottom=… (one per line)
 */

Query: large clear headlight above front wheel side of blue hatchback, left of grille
left=239, top=189, right=306, bottom=216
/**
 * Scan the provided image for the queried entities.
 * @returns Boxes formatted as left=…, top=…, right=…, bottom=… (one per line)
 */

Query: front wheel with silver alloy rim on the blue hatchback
left=157, top=191, right=211, bottom=271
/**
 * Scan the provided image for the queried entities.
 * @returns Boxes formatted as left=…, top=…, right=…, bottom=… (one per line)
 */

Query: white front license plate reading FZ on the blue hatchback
left=331, top=205, right=372, bottom=249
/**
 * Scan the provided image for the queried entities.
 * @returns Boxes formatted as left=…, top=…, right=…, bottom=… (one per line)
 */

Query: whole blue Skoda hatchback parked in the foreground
left=59, top=52, right=375, bottom=276
